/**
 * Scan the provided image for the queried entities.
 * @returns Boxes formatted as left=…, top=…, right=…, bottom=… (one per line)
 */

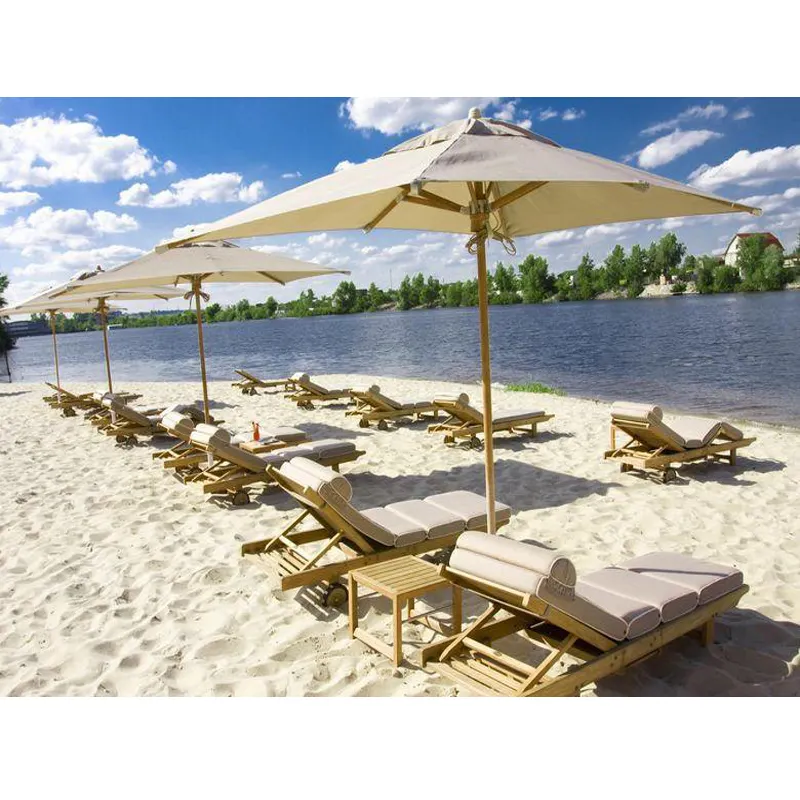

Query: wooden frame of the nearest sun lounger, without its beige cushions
left=420, top=567, right=749, bottom=697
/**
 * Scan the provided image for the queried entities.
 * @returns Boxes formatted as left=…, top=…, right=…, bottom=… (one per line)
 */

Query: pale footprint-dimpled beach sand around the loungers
left=0, top=376, right=800, bottom=695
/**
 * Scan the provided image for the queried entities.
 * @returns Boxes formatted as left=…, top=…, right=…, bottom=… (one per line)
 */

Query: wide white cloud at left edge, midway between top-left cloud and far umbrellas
left=0, top=206, right=139, bottom=253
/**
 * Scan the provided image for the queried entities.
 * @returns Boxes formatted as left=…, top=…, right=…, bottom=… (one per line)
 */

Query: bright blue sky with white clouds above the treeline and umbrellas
left=0, top=97, right=800, bottom=310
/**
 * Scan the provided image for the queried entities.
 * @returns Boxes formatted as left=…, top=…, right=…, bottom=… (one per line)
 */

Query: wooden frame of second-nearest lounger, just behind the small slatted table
left=241, top=466, right=510, bottom=604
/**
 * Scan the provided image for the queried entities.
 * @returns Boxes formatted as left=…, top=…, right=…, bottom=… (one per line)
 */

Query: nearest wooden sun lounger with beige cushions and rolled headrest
left=421, top=532, right=748, bottom=697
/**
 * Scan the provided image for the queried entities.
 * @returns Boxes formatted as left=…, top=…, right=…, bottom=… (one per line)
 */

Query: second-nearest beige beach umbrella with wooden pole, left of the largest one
left=54, top=241, right=350, bottom=422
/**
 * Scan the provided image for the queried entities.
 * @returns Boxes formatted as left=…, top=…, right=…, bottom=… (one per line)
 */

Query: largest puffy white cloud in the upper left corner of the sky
left=0, top=117, right=156, bottom=189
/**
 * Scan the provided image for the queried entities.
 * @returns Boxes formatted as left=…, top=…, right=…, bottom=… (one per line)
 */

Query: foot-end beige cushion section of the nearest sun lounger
left=619, top=553, right=744, bottom=605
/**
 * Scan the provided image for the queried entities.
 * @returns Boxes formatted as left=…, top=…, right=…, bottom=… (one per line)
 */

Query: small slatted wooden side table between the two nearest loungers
left=348, top=556, right=461, bottom=667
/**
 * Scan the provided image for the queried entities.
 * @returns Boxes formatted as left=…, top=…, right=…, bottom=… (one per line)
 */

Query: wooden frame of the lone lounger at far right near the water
left=603, top=420, right=756, bottom=482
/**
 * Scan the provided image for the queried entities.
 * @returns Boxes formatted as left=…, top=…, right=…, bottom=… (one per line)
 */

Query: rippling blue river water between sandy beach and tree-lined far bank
left=6, top=292, right=800, bottom=425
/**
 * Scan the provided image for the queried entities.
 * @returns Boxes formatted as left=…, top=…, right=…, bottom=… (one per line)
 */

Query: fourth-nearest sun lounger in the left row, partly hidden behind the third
left=153, top=412, right=309, bottom=478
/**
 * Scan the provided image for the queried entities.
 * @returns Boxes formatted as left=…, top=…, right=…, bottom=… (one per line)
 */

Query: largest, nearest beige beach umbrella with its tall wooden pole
left=163, top=109, right=758, bottom=532
